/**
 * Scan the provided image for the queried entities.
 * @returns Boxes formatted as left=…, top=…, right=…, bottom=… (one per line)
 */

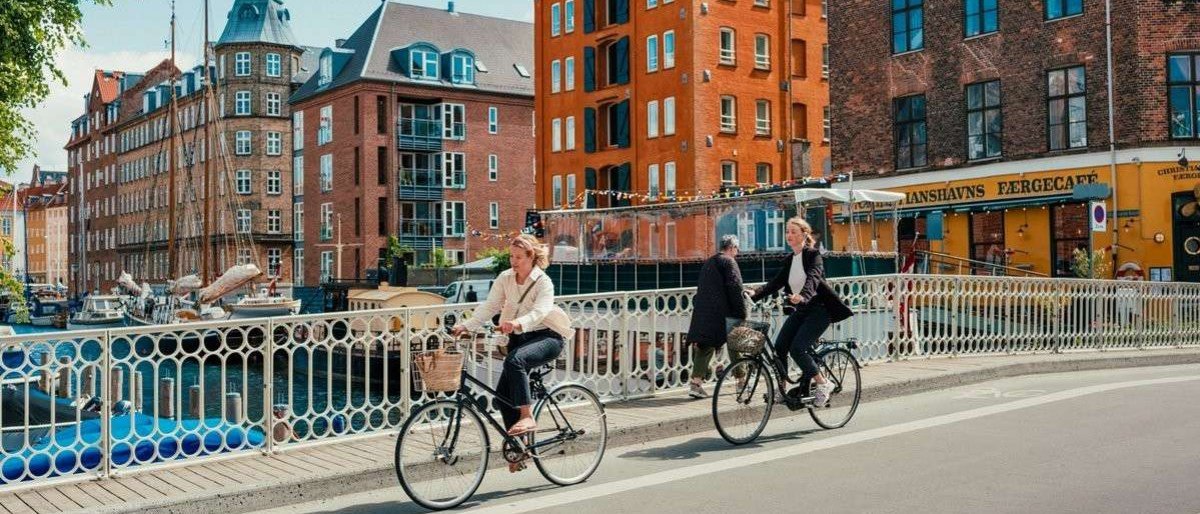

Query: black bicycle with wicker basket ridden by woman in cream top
left=395, top=334, right=608, bottom=510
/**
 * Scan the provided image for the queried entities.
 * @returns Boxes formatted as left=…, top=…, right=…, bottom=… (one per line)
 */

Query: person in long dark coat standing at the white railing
left=688, top=235, right=746, bottom=398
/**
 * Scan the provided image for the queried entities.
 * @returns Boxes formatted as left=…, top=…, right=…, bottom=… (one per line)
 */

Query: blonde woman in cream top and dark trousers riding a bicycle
left=452, top=234, right=569, bottom=471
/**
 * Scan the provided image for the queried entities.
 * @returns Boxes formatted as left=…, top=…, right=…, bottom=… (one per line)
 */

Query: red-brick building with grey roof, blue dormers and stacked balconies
left=290, top=1, right=534, bottom=286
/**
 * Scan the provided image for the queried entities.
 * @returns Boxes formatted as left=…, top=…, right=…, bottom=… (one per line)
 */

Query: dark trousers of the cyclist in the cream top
left=496, top=329, right=563, bottom=428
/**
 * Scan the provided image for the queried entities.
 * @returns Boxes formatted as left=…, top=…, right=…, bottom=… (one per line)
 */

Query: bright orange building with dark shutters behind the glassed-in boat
left=534, top=0, right=829, bottom=259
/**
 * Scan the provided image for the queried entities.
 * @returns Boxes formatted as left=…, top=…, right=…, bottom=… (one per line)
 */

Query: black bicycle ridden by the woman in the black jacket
left=713, top=334, right=863, bottom=444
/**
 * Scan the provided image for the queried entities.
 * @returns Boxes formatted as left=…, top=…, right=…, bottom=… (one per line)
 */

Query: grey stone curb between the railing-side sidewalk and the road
left=88, top=351, right=1200, bottom=514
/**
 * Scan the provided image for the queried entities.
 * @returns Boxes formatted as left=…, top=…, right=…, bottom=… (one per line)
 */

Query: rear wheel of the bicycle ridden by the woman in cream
left=532, top=384, right=608, bottom=485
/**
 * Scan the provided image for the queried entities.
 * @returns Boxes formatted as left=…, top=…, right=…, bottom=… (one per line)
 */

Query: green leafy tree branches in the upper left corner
left=0, top=0, right=112, bottom=173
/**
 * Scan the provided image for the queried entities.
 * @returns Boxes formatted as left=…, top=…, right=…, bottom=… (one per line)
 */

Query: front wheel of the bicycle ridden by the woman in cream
left=396, top=400, right=488, bottom=510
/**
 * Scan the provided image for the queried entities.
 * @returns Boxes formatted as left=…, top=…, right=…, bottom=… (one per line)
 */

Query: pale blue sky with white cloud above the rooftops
left=11, top=0, right=533, bottom=183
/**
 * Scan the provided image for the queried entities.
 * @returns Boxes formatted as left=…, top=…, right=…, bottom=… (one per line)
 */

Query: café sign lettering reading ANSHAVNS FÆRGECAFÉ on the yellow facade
left=905, top=173, right=1099, bottom=205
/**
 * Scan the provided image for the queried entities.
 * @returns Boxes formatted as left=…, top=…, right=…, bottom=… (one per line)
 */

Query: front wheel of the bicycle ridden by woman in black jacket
left=713, top=357, right=775, bottom=444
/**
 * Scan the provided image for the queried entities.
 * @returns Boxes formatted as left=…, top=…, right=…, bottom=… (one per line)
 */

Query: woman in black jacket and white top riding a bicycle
left=751, top=216, right=853, bottom=407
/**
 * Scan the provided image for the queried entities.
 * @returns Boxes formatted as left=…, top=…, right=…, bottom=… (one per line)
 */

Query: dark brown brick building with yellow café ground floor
left=829, top=0, right=1200, bottom=281
